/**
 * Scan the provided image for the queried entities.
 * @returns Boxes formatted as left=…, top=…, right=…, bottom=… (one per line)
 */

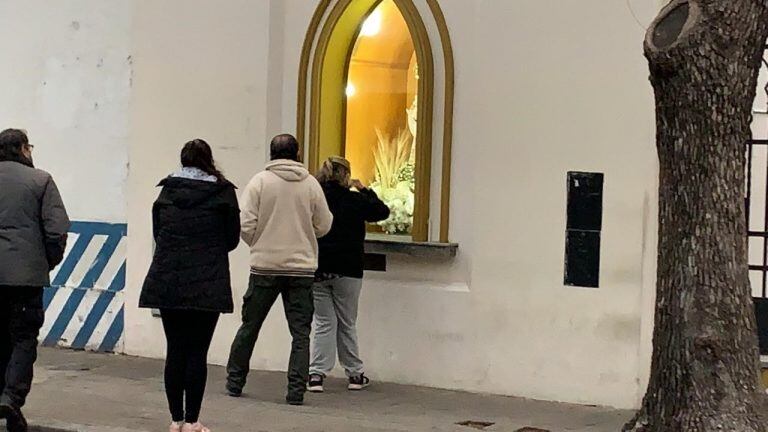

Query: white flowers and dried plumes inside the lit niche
left=371, top=128, right=415, bottom=234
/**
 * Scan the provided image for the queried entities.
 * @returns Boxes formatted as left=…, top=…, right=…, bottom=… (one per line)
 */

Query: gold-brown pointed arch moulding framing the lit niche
left=296, top=0, right=454, bottom=243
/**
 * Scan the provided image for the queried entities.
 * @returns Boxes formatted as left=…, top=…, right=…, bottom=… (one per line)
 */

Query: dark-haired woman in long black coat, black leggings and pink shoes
left=139, top=139, right=240, bottom=432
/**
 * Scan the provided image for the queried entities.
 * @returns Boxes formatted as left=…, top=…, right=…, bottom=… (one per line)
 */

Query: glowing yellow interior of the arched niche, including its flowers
left=343, top=0, right=419, bottom=236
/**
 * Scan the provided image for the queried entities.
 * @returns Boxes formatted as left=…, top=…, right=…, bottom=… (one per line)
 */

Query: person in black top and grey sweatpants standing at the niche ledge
left=308, top=157, right=389, bottom=392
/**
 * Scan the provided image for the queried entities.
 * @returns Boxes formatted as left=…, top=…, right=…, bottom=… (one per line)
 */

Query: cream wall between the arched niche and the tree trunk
left=286, top=0, right=657, bottom=407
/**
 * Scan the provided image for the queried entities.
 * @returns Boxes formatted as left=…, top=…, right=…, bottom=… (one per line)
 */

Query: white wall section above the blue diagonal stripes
left=0, top=0, right=134, bottom=223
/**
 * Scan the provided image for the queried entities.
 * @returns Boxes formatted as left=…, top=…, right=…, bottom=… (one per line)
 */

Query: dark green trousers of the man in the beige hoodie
left=227, top=275, right=314, bottom=400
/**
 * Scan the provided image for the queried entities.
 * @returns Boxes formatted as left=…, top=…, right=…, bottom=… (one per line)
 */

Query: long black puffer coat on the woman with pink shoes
left=139, top=177, right=240, bottom=313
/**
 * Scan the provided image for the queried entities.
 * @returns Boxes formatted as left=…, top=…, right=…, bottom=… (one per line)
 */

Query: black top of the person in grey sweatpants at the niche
left=317, top=182, right=389, bottom=278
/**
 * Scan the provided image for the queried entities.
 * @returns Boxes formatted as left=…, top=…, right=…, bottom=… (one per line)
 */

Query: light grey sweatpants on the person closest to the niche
left=309, top=278, right=363, bottom=377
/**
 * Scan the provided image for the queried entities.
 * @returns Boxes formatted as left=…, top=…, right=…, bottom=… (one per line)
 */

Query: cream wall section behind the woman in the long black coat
left=125, top=0, right=284, bottom=367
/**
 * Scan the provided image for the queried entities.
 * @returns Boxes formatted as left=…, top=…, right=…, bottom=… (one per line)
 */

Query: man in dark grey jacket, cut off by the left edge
left=0, top=129, right=69, bottom=432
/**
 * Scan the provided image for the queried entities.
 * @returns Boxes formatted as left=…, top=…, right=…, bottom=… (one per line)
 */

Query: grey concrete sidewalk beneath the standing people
left=0, top=349, right=632, bottom=432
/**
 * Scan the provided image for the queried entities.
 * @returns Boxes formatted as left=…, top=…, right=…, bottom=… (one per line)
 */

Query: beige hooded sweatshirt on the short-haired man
left=240, top=159, right=333, bottom=277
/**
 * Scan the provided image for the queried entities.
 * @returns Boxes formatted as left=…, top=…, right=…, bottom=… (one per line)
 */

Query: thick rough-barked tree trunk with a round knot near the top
left=624, top=0, right=768, bottom=432
